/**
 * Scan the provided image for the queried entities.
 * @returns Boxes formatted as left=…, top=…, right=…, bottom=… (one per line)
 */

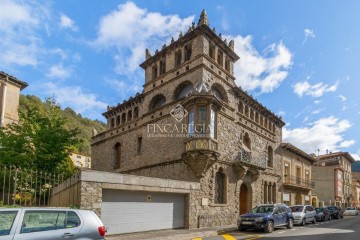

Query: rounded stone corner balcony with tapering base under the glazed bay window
left=182, top=137, right=220, bottom=178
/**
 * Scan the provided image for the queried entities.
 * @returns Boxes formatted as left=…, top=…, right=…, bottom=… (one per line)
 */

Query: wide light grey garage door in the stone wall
left=101, top=189, right=185, bottom=234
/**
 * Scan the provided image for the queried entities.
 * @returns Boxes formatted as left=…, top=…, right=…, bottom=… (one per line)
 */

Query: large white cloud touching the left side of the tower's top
left=92, top=2, right=194, bottom=74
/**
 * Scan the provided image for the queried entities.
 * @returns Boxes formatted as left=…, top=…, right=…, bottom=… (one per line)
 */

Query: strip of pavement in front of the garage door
left=106, top=225, right=237, bottom=240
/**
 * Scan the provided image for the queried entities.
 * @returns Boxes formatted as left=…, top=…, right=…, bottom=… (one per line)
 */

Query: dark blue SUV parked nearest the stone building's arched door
left=238, top=203, right=294, bottom=233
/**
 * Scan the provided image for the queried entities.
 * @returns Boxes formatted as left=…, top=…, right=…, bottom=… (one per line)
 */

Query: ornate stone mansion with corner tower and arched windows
left=91, top=12, right=284, bottom=228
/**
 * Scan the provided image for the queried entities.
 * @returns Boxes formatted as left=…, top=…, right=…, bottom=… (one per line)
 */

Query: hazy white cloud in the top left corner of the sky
left=0, top=0, right=50, bottom=66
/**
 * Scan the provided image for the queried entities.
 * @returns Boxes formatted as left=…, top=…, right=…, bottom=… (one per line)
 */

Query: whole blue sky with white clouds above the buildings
left=0, top=0, right=360, bottom=159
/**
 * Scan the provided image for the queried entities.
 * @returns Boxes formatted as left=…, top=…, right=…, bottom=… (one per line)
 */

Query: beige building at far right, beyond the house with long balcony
left=312, top=152, right=355, bottom=208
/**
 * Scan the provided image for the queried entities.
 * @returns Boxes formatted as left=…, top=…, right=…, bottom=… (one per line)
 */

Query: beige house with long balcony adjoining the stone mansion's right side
left=281, top=143, right=317, bottom=206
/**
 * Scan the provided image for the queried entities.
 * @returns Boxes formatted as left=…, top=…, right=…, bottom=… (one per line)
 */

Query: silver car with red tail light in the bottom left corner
left=0, top=208, right=106, bottom=240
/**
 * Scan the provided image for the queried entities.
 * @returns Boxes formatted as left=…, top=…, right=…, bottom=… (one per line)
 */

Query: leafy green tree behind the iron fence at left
left=0, top=98, right=80, bottom=175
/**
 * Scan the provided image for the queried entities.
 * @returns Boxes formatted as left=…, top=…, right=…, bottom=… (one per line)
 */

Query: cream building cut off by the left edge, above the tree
left=0, top=71, right=28, bottom=127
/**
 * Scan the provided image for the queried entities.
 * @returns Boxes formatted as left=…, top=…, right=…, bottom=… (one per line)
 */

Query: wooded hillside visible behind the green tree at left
left=20, top=95, right=105, bottom=156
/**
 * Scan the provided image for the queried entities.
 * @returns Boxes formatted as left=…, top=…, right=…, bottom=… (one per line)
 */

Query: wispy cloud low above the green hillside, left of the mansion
left=44, top=83, right=108, bottom=118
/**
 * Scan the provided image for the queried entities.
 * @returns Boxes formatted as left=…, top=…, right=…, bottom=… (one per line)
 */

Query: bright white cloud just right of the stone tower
left=230, top=35, right=293, bottom=93
